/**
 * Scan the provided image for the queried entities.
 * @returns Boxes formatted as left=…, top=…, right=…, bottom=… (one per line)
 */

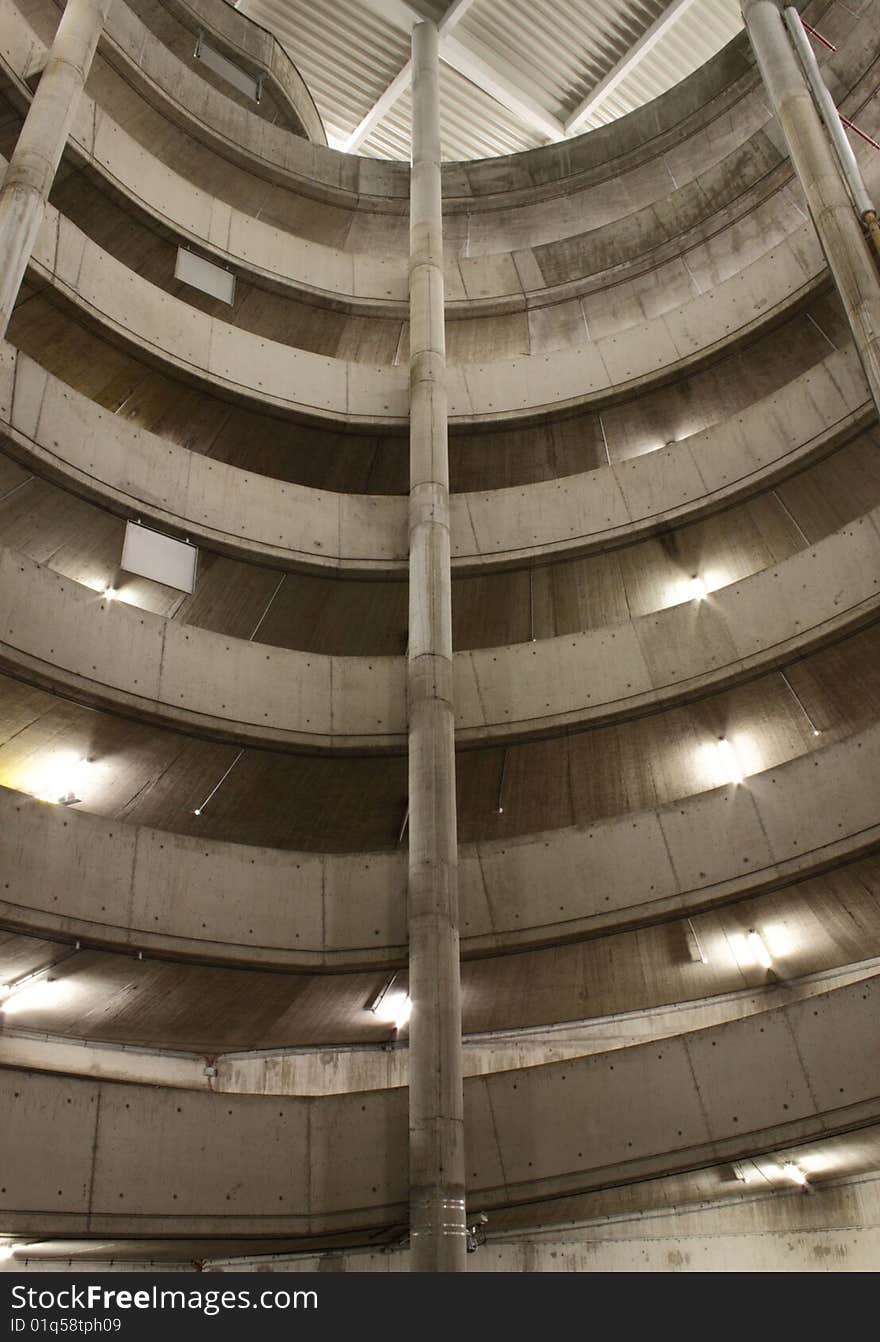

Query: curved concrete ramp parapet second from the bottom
left=0, top=729, right=880, bottom=968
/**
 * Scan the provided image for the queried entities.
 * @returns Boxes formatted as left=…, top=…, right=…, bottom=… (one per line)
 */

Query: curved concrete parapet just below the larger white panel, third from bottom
left=0, top=493, right=880, bottom=753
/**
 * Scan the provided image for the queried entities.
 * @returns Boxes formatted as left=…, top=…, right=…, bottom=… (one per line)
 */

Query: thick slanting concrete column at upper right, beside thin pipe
left=742, top=0, right=880, bottom=413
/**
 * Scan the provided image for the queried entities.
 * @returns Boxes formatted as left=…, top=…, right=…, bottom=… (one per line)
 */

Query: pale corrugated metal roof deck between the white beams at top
left=239, top=0, right=742, bottom=160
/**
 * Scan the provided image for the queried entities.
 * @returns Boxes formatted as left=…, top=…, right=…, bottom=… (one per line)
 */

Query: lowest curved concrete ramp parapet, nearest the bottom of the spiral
left=0, top=982, right=879, bottom=1236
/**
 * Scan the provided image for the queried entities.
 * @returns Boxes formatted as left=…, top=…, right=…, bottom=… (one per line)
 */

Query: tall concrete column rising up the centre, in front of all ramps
left=406, top=23, right=467, bottom=1272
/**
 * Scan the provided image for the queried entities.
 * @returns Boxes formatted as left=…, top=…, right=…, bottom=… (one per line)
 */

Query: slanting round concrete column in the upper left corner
left=0, top=0, right=111, bottom=338
